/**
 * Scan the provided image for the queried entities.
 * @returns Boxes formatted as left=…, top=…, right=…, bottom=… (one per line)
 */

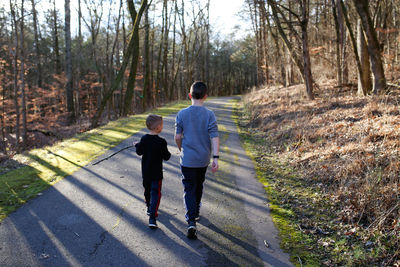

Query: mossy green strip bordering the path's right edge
left=235, top=99, right=333, bottom=266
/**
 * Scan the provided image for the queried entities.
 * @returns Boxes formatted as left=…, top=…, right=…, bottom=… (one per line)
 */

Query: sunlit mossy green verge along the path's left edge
left=0, top=101, right=189, bottom=221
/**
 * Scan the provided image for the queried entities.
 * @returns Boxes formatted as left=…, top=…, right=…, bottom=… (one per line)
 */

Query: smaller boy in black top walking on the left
left=133, top=114, right=171, bottom=229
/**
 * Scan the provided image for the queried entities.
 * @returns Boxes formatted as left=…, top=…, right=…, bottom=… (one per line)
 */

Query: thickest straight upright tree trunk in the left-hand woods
left=65, top=0, right=75, bottom=124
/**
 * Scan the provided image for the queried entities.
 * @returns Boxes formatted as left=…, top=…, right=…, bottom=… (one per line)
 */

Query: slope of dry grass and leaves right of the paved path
left=239, top=83, right=400, bottom=266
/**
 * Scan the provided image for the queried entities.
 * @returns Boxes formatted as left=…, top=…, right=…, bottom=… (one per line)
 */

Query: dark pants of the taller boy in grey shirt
left=181, top=166, right=207, bottom=224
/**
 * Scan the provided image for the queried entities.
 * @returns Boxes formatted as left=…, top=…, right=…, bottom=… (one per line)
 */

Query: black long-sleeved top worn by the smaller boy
left=135, top=134, right=171, bottom=181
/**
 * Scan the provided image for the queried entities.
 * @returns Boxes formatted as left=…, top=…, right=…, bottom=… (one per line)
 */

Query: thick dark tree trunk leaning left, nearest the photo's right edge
left=353, top=0, right=386, bottom=94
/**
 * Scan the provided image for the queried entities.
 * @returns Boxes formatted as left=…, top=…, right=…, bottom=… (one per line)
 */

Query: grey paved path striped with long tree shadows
left=0, top=98, right=291, bottom=266
